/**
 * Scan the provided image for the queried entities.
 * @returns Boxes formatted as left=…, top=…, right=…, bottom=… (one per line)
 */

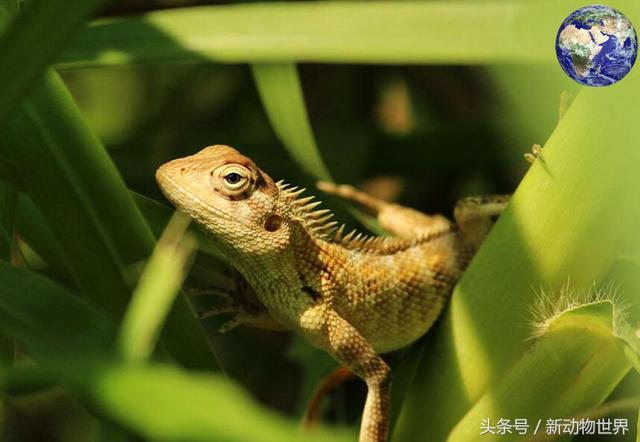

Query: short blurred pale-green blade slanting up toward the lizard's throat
left=118, top=212, right=196, bottom=361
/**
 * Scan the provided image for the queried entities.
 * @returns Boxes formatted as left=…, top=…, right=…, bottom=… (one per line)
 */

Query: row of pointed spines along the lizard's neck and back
left=276, top=181, right=450, bottom=255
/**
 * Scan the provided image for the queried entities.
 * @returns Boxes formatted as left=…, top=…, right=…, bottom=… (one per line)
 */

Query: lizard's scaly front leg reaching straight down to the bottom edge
left=325, top=309, right=391, bottom=442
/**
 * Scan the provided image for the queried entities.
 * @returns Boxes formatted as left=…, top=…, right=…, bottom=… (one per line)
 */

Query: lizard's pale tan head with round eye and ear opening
left=156, top=145, right=288, bottom=253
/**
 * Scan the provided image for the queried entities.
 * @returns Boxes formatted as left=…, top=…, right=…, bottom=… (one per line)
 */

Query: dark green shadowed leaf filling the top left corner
left=0, top=0, right=108, bottom=120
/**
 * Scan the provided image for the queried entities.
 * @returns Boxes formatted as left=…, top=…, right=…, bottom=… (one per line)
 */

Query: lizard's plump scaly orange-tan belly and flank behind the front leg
left=335, top=235, right=465, bottom=353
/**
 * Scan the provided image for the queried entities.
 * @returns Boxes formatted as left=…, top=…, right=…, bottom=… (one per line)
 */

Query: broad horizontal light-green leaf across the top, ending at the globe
left=58, top=0, right=583, bottom=68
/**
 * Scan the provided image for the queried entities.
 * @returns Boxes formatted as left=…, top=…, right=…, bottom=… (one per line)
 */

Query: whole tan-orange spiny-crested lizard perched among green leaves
left=156, top=145, right=509, bottom=442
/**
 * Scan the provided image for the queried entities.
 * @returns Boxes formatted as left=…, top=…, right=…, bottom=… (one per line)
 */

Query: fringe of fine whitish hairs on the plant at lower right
left=529, top=279, right=634, bottom=339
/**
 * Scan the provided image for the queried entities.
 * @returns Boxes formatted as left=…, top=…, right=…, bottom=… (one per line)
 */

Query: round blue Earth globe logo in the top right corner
left=556, top=5, right=638, bottom=86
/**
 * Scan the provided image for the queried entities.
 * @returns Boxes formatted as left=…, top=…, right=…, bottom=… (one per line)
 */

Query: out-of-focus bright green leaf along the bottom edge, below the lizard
left=60, top=364, right=353, bottom=442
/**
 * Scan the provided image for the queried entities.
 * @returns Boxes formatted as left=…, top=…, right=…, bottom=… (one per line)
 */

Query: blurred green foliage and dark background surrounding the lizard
left=0, top=0, right=640, bottom=441
